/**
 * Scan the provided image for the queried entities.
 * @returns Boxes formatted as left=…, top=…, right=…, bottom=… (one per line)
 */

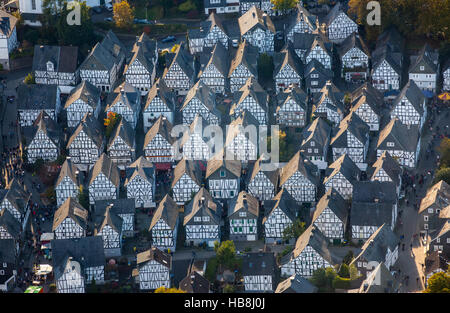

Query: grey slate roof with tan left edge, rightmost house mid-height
left=377, top=117, right=419, bottom=152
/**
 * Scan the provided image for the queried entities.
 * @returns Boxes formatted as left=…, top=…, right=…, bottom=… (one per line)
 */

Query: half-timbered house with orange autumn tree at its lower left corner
left=105, top=82, right=141, bottom=129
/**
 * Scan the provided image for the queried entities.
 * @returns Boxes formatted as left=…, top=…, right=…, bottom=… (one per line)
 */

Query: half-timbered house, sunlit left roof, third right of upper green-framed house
left=323, top=154, right=361, bottom=200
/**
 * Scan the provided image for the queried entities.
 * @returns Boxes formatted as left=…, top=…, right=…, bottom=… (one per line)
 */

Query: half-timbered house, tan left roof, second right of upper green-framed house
left=280, top=151, right=319, bottom=203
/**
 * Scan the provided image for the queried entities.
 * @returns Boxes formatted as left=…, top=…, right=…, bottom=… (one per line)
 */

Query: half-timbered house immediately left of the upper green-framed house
left=171, top=158, right=202, bottom=204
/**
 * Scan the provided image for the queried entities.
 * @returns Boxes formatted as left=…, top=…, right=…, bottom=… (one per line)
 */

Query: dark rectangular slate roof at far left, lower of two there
left=17, top=84, right=58, bottom=110
